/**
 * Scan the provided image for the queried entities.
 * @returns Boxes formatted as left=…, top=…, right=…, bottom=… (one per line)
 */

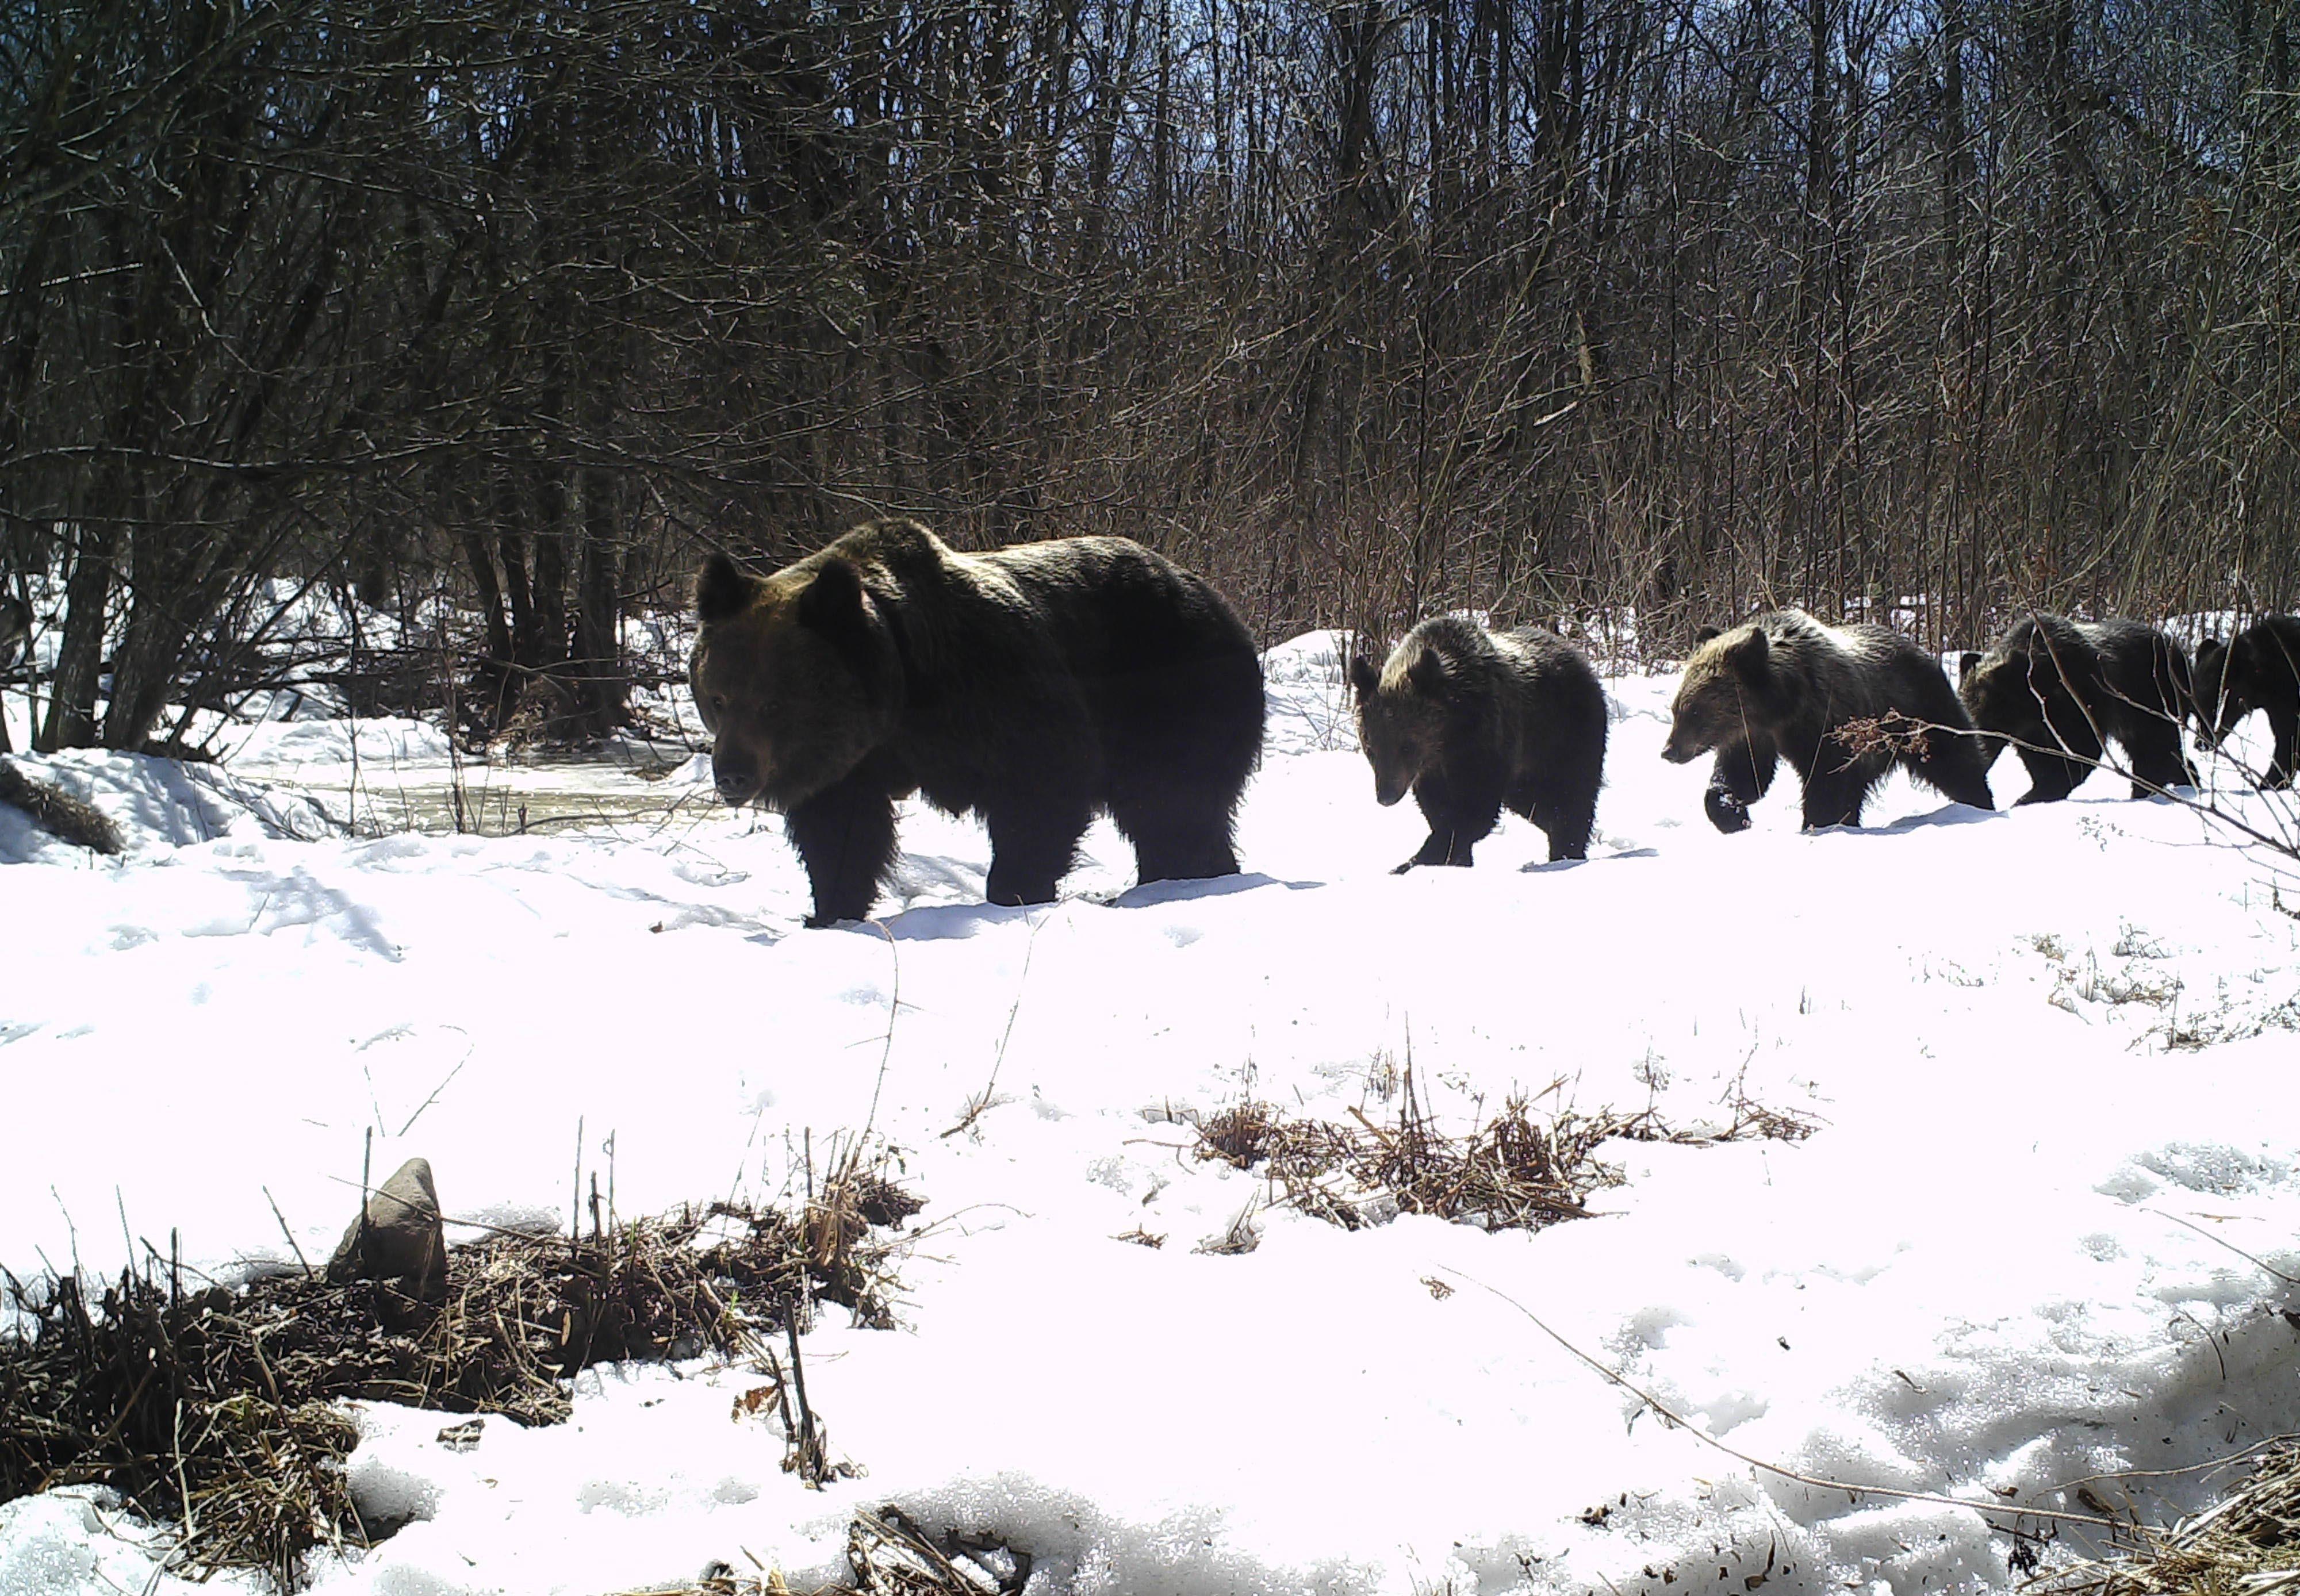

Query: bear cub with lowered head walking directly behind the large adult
left=1350, top=616, right=1605, bottom=872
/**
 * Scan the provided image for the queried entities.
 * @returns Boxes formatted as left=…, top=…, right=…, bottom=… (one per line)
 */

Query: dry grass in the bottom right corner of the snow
left=2031, top=1444, right=2300, bottom=1596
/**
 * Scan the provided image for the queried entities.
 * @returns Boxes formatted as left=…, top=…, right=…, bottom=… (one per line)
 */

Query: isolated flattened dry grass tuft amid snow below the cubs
left=1194, top=1067, right=1815, bottom=1230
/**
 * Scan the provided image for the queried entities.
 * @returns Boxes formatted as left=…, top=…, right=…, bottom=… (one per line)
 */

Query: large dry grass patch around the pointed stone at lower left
left=0, top=1159, right=920, bottom=1589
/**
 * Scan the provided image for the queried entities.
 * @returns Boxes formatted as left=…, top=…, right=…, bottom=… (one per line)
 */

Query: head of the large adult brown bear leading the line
left=688, top=554, right=902, bottom=814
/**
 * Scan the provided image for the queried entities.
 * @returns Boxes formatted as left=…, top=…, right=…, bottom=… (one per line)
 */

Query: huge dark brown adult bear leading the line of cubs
left=688, top=520, right=1263, bottom=924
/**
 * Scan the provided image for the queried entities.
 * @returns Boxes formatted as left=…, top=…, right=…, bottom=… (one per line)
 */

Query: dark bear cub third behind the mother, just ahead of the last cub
left=1957, top=614, right=2196, bottom=805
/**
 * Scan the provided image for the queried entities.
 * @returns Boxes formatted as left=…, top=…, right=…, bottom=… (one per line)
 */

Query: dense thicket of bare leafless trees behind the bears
left=0, top=0, right=2300, bottom=747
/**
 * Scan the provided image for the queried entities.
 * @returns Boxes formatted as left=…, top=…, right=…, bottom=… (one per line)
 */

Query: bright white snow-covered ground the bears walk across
left=0, top=637, right=2300, bottom=1596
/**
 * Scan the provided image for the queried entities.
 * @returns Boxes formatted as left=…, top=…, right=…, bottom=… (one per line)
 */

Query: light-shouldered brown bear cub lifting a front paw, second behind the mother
left=1661, top=609, right=1996, bottom=832
